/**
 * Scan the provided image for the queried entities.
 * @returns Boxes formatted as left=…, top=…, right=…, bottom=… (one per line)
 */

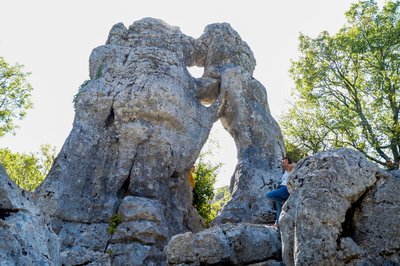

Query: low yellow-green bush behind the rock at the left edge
left=0, top=144, right=56, bottom=191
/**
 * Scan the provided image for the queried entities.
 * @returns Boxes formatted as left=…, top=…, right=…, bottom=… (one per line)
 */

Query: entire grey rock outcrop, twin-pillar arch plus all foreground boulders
left=0, top=18, right=400, bottom=266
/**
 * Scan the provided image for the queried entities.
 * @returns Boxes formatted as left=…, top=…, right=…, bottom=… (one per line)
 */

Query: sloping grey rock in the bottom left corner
left=0, top=166, right=60, bottom=265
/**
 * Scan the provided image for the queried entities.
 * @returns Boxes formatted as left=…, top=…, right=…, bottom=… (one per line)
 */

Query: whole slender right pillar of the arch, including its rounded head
left=196, top=23, right=284, bottom=224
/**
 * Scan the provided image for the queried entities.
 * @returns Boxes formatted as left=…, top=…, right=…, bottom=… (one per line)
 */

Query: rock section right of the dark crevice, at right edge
left=348, top=171, right=400, bottom=265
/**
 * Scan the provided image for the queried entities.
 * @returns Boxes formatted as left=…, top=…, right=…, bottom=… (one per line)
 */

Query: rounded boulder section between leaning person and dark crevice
left=280, top=149, right=377, bottom=265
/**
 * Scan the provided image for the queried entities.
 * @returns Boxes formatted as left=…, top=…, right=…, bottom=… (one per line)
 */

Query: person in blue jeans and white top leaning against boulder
left=266, top=157, right=294, bottom=227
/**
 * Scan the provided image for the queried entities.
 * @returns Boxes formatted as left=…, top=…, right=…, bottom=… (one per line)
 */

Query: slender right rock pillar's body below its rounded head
left=213, top=67, right=284, bottom=224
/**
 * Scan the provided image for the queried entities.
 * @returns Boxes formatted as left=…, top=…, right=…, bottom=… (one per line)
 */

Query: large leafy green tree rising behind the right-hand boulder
left=281, top=0, right=400, bottom=168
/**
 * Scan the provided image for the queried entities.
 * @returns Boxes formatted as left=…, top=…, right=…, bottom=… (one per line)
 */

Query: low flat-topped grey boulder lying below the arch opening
left=165, top=223, right=281, bottom=265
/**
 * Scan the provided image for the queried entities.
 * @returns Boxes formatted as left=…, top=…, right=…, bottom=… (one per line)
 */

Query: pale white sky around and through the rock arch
left=0, top=0, right=382, bottom=187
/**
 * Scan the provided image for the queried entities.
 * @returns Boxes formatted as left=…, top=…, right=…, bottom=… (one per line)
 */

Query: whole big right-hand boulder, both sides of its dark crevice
left=280, top=149, right=400, bottom=265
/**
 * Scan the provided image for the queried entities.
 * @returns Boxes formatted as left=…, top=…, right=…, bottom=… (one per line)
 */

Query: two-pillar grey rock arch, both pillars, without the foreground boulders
left=36, top=18, right=283, bottom=265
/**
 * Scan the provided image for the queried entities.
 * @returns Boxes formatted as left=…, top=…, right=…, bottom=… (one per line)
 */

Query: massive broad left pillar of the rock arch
left=36, top=18, right=223, bottom=265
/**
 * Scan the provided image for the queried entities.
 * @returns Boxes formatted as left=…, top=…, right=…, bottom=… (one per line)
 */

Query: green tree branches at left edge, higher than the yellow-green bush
left=0, top=57, right=32, bottom=137
